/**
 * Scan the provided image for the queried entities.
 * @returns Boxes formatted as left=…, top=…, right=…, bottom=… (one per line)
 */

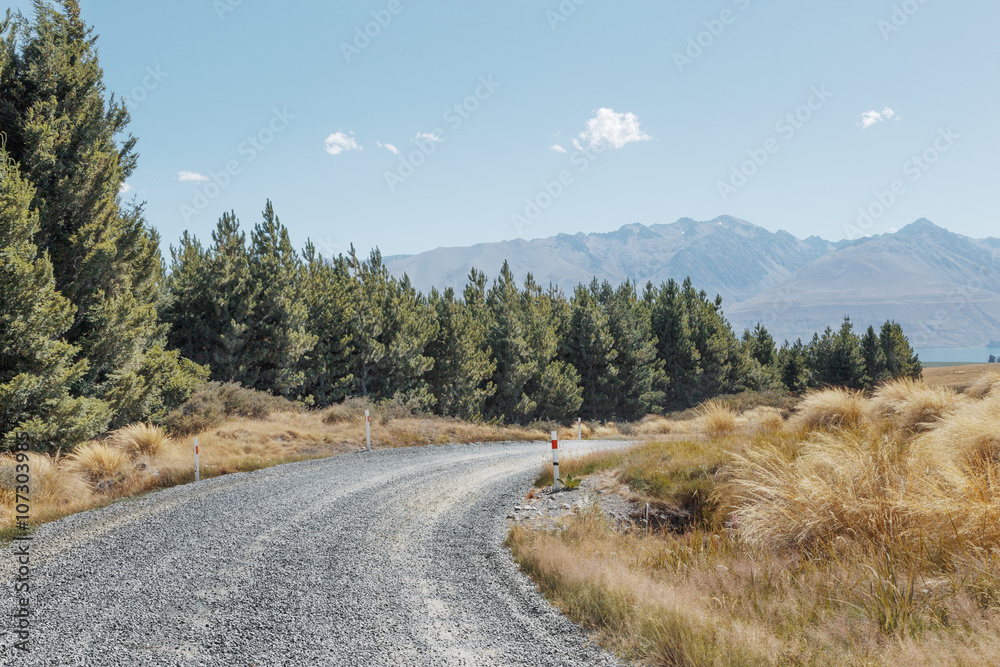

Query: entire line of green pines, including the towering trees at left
left=0, top=0, right=920, bottom=449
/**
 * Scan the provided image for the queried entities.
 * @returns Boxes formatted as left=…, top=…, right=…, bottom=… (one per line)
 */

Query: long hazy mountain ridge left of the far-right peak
left=386, top=216, right=835, bottom=303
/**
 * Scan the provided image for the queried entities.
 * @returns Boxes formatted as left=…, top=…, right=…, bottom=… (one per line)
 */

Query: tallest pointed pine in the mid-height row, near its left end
left=242, top=200, right=316, bottom=398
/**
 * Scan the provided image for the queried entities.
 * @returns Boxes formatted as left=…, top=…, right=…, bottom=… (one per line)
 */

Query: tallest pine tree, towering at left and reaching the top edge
left=0, top=0, right=203, bottom=426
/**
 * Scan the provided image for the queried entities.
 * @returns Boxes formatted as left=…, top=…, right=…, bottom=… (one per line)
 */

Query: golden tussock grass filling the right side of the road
left=508, top=374, right=1000, bottom=666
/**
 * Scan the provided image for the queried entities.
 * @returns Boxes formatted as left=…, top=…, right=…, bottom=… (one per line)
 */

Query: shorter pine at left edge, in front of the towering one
left=0, top=145, right=111, bottom=450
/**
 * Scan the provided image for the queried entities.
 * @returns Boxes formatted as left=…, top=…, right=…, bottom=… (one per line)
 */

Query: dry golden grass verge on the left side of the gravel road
left=0, top=385, right=548, bottom=543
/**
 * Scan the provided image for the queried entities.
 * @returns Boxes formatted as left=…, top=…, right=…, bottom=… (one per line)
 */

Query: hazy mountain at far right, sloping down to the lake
left=726, top=220, right=1000, bottom=348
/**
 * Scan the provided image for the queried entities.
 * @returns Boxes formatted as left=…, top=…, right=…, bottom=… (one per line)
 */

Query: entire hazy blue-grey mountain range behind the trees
left=385, top=216, right=1000, bottom=348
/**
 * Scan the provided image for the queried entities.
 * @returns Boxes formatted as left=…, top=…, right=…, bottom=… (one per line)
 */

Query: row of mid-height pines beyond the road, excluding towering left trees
left=163, top=202, right=921, bottom=422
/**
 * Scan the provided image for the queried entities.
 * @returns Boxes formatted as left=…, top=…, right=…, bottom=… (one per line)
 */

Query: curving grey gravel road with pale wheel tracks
left=0, top=442, right=624, bottom=667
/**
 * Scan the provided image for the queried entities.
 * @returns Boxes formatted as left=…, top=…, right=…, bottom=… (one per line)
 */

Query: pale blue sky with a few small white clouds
left=3, top=0, right=1000, bottom=255
